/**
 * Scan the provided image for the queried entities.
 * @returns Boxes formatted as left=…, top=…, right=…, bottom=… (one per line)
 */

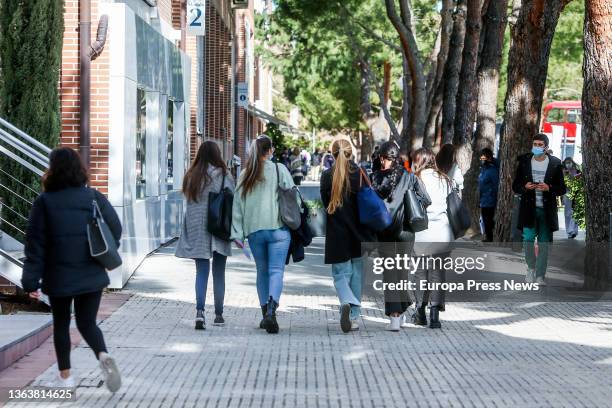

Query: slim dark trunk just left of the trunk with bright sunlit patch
left=442, top=0, right=467, bottom=144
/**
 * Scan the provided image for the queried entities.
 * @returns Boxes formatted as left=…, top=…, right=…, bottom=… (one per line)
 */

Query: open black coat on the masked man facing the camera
left=512, top=153, right=566, bottom=231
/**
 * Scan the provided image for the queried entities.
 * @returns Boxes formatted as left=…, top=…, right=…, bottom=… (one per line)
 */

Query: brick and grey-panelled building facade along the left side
left=59, top=0, right=272, bottom=288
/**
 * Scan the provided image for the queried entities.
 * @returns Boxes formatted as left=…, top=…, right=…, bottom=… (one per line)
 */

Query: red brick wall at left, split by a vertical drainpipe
left=59, top=0, right=111, bottom=194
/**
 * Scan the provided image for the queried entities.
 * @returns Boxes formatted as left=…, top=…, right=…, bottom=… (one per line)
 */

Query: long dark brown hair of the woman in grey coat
left=183, top=140, right=227, bottom=203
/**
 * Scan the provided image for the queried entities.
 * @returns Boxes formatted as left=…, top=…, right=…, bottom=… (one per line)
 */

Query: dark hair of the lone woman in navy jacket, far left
left=42, top=147, right=89, bottom=192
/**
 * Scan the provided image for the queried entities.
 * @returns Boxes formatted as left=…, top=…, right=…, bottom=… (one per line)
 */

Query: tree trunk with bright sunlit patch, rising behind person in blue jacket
left=463, top=0, right=508, bottom=233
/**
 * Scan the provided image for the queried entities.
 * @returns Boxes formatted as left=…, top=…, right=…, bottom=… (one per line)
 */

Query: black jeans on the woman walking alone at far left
left=49, top=291, right=106, bottom=370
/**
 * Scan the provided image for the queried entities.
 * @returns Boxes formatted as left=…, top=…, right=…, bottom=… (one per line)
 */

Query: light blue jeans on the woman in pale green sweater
left=248, top=227, right=291, bottom=306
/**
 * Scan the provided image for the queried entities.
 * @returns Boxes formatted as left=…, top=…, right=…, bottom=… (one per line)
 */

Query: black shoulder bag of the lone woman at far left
left=87, top=190, right=122, bottom=271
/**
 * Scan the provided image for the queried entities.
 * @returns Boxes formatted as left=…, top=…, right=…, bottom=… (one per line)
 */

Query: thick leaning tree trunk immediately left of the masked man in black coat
left=495, top=0, right=570, bottom=242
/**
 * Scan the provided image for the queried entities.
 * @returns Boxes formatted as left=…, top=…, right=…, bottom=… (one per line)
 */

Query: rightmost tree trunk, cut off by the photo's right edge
left=582, top=0, right=612, bottom=289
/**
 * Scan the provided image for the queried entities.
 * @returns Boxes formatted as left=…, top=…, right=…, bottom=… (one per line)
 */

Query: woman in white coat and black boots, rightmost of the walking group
left=412, top=148, right=454, bottom=329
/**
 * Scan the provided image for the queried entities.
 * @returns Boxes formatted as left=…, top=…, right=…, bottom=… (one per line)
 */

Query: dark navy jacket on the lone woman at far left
left=21, top=187, right=121, bottom=296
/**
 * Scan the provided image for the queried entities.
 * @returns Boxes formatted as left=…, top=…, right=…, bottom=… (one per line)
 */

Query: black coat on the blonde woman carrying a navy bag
left=321, top=162, right=376, bottom=264
